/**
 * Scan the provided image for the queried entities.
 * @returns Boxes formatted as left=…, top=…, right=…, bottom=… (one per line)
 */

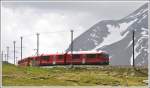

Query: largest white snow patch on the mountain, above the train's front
left=93, top=19, right=137, bottom=50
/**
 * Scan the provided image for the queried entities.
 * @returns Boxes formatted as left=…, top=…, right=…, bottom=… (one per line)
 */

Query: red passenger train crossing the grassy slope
left=18, top=51, right=109, bottom=66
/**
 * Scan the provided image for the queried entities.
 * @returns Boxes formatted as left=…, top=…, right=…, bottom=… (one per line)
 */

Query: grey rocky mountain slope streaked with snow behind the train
left=66, top=3, right=148, bottom=65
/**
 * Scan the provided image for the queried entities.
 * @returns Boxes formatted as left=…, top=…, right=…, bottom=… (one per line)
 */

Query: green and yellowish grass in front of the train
left=2, top=64, right=148, bottom=86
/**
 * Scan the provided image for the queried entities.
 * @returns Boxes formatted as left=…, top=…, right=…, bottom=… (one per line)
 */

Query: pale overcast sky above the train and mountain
left=1, top=2, right=145, bottom=62
